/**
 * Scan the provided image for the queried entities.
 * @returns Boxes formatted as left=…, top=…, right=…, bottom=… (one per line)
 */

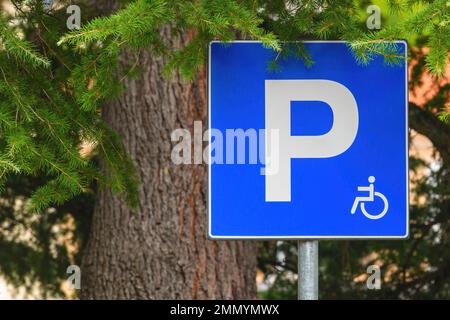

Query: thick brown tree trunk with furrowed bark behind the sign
left=81, top=28, right=256, bottom=299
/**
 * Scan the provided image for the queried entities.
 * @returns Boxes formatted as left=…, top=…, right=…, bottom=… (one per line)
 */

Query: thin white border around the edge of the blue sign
left=207, top=40, right=409, bottom=240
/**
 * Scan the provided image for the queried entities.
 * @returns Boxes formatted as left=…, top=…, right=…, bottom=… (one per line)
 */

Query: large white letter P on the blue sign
left=265, top=80, right=359, bottom=202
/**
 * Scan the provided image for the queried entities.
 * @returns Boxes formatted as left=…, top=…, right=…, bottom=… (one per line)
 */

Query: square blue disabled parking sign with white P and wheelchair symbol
left=208, top=41, right=408, bottom=239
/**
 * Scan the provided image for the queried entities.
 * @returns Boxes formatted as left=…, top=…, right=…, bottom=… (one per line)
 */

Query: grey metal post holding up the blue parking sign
left=298, top=240, right=319, bottom=300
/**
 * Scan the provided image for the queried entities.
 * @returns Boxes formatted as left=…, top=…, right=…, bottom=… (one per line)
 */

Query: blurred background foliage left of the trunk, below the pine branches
left=0, top=175, right=94, bottom=299
